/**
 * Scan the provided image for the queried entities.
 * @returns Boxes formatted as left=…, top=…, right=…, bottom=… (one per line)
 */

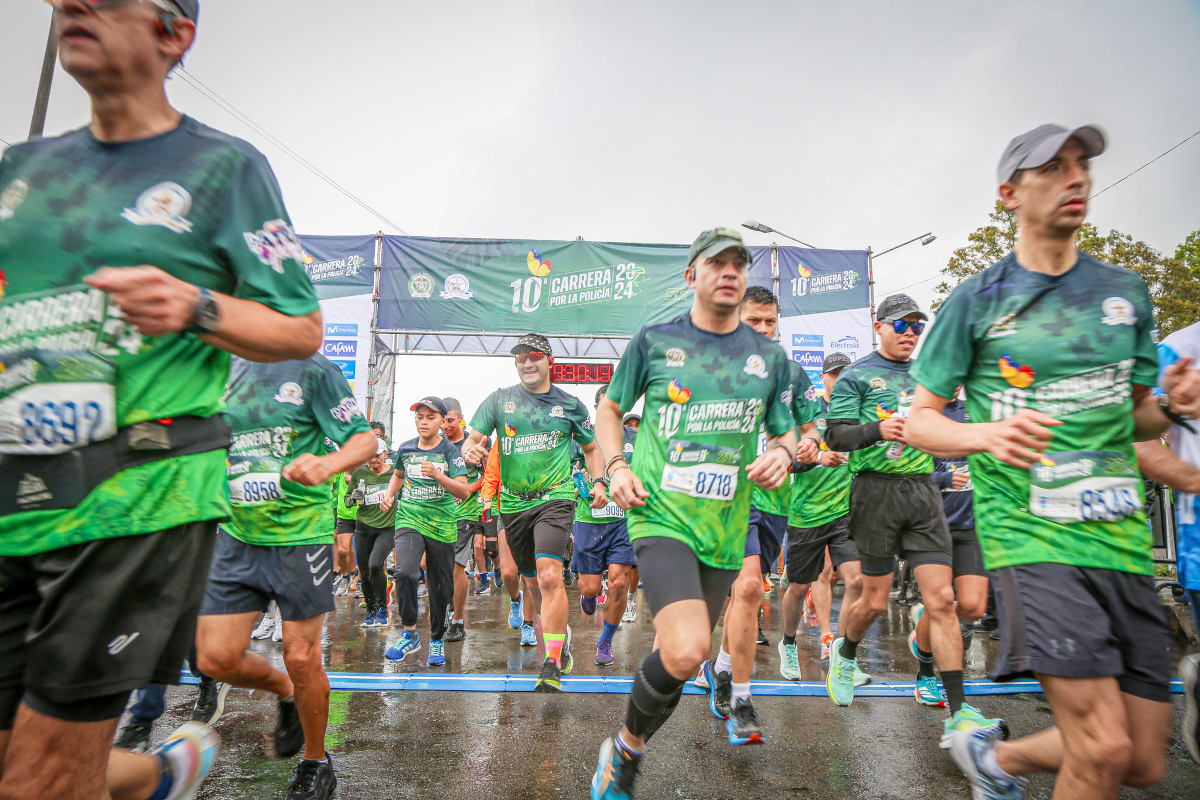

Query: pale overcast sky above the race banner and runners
left=0, top=0, right=1200, bottom=438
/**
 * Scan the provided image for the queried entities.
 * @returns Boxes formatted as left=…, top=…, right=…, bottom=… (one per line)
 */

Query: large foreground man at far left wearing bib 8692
left=0, top=0, right=322, bottom=796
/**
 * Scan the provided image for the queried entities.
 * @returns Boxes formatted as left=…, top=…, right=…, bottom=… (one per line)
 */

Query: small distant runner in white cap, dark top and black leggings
left=344, top=439, right=396, bottom=627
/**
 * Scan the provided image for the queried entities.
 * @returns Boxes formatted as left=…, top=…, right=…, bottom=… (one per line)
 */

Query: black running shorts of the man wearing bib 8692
left=0, top=522, right=217, bottom=729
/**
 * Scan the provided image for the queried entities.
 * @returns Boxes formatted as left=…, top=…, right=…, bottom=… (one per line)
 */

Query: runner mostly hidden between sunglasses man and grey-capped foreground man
left=908, top=390, right=988, bottom=708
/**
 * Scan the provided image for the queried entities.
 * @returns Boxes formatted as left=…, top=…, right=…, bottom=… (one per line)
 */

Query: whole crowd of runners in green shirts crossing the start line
left=0, top=0, right=1200, bottom=800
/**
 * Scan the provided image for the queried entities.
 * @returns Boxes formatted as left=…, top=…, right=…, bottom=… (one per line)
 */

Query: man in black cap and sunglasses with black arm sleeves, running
left=826, top=294, right=1000, bottom=736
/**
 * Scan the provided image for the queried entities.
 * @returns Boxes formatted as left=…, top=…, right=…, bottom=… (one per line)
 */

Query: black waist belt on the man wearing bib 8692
left=0, top=414, right=232, bottom=516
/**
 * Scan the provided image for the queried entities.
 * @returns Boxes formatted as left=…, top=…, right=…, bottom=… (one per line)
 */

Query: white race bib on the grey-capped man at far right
left=1030, top=450, right=1142, bottom=522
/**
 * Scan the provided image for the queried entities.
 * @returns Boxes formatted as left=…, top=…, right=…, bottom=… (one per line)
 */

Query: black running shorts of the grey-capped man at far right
left=992, top=564, right=1171, bottom=703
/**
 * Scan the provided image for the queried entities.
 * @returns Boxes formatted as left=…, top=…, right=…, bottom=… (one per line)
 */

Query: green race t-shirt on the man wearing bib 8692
left=0, top=116, right=318, bottom=555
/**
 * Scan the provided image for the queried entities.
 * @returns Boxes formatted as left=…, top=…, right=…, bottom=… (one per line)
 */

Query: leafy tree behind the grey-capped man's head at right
left=934, top=208, right=1200, bottom=336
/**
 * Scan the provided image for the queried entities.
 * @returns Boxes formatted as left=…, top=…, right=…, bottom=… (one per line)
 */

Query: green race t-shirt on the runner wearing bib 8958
left=222, top=355, right=371, bottom=546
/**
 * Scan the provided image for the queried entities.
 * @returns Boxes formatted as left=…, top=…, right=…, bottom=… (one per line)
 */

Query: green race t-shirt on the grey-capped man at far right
left=913, top=253, right=1158, bottom=575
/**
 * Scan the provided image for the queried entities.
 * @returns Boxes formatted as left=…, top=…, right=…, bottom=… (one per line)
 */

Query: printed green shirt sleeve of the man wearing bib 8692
left=212, top=151, right=319, bottom=317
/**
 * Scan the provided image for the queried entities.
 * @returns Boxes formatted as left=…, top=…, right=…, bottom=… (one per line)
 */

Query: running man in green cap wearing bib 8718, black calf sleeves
left=592, top=228, right=798, bottom=800
